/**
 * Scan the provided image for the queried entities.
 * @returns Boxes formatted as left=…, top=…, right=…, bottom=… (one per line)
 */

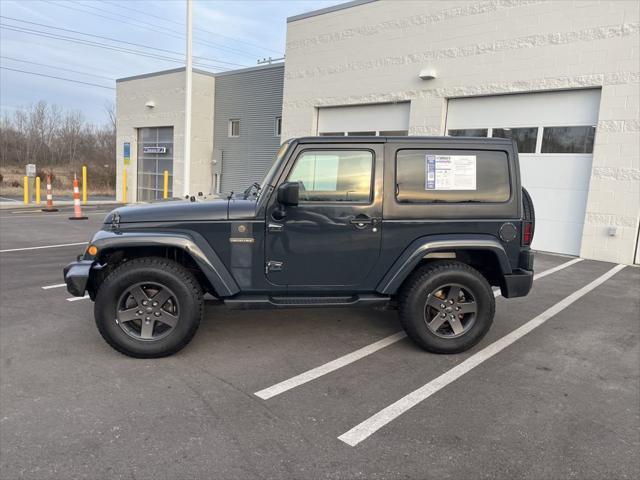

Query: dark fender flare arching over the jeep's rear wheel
left=376, top=234, right=512, bottom=295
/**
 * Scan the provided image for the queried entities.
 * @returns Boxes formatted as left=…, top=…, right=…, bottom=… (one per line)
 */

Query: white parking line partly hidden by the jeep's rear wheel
left=255, top=258, right=582, bottom=400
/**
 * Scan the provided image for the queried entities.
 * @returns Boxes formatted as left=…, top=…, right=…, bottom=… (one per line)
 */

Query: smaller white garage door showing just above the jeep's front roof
left=318, top=102, right=410, bottom=136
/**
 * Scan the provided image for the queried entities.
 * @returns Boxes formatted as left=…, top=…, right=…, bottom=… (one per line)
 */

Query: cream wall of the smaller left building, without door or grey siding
left=116, top=69, right=215, bottom=202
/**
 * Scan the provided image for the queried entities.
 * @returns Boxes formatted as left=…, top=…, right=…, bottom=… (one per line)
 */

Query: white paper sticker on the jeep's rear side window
left=424, top=155, right=476, bottom=190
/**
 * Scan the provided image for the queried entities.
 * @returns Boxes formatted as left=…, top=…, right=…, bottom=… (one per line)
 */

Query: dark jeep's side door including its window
left=265, top=144, right=383, bottom=290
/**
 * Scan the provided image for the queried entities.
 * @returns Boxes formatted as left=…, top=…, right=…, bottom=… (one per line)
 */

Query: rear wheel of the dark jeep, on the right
left=399, top=261, right=495, bottom=354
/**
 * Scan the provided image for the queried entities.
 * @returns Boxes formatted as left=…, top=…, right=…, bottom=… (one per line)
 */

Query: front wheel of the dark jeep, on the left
left=94, top=257, right=203, bottom=358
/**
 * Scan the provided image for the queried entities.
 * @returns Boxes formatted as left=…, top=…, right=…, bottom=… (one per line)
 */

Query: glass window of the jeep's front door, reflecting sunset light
left=287, top=150, right=373, bottom=203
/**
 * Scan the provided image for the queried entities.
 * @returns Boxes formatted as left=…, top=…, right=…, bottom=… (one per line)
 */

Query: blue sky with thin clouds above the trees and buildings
left=0, top=0, right=343, bottom=123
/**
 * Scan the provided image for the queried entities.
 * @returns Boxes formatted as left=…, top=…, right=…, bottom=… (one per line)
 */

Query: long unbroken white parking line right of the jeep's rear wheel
left=338, top=265, right=625, bottom=447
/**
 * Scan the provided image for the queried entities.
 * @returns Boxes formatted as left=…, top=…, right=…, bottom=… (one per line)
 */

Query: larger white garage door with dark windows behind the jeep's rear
left=447, top=89, right=600, bottom=255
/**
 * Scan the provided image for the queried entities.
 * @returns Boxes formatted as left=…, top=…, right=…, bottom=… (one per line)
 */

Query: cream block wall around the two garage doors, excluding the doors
left=283, top=0, right=640, bottom=263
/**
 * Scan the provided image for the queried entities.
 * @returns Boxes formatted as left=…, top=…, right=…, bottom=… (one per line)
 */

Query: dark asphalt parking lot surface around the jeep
left=0, top=209, right=640, bottom=480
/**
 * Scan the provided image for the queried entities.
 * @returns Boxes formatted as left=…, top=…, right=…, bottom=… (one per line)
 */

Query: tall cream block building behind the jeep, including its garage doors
left=283, top=0, right=640, bottom=263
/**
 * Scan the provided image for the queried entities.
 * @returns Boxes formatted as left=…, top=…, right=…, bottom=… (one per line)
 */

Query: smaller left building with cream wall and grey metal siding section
left=116, top=63, right=284, bottom=202
